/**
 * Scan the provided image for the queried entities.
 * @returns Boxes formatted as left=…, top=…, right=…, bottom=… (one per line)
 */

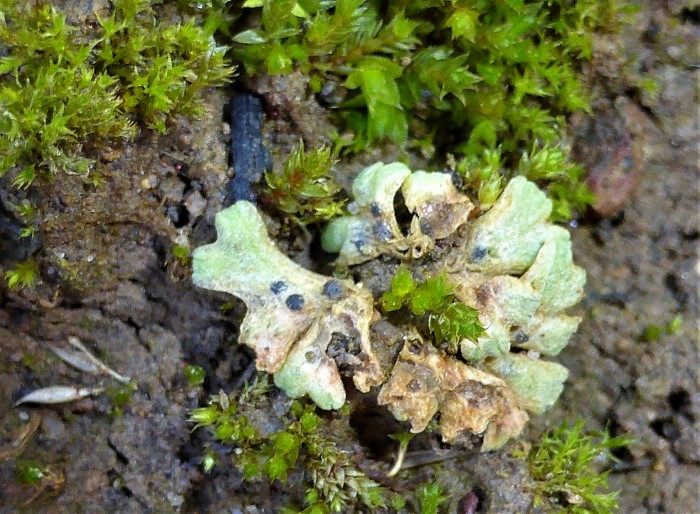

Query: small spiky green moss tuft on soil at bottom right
left=527, top=421, right=632, bottom=514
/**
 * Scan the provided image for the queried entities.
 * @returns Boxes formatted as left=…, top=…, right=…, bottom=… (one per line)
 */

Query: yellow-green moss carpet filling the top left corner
left=0, top=0, right=233, bottom=188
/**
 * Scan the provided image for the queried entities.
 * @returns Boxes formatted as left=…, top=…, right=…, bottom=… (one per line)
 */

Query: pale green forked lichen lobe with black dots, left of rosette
left=192, top=201, right=384, bottom=409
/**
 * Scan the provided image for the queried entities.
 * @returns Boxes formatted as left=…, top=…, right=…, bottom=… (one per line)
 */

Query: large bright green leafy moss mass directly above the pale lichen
left=232, top=0, right=626, bottom=218
